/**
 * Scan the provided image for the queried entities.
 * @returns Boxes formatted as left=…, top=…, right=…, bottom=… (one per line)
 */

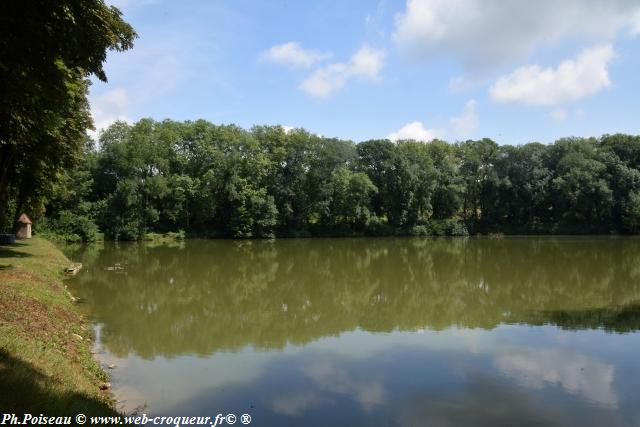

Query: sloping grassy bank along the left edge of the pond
left=0, top=237, right=115, bottom=415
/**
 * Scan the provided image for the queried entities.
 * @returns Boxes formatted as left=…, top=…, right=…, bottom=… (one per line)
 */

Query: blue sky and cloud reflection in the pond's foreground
left=148, top=328, right=639, bottom=426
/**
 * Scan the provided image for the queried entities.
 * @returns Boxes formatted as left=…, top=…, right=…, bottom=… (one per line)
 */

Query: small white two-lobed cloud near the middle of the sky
left=300, top=46, right=385, bottom=98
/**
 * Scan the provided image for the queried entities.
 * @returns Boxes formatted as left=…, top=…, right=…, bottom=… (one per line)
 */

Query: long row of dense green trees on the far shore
left=38, top=119, right=640, bottom=240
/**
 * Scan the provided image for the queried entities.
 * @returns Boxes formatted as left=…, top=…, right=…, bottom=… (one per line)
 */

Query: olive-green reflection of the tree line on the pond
left=63, top=238, right=640, bottom=358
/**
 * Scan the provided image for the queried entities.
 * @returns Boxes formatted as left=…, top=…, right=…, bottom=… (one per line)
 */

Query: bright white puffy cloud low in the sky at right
left=489, top=45, right=614, bottom=105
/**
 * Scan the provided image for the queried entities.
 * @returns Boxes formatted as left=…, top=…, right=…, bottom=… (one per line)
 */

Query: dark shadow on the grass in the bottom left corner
left=0, top=349, right=117, bottom=416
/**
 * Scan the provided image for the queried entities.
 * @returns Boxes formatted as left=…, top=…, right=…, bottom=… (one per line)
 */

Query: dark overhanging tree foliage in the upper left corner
left=0, top=0, right=136, bottom=231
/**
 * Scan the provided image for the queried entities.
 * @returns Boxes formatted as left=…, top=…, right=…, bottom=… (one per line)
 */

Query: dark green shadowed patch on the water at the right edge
left=527, top=303, right=640, bottom=333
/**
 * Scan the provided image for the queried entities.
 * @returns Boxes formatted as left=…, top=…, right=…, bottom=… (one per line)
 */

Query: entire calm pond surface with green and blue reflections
left=61, top=237, right=640, bottom=426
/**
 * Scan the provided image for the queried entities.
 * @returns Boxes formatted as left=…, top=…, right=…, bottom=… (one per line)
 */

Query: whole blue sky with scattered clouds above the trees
left=90, top=0, right=640, bottom=144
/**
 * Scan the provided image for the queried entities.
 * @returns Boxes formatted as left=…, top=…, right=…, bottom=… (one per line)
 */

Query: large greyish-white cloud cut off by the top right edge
left=393, top=0, right=640, bottom=68
